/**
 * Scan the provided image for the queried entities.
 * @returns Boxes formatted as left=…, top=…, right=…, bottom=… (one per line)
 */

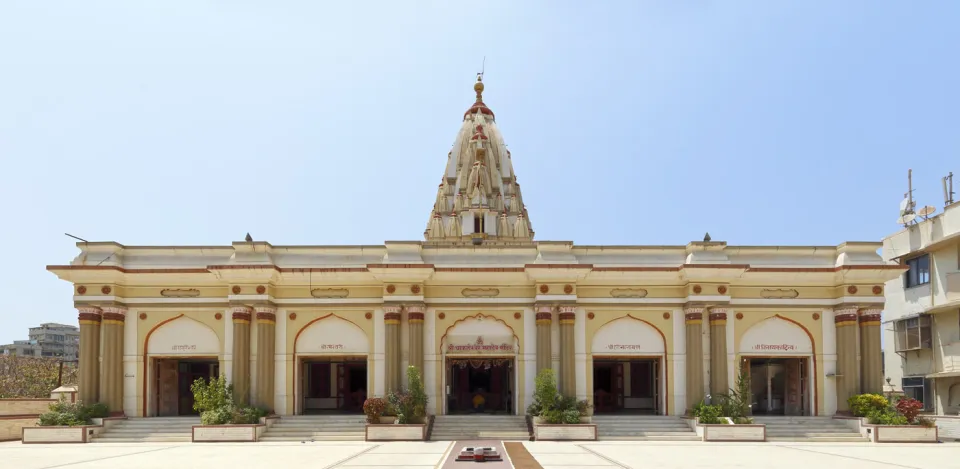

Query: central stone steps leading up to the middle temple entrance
left=430, top=415, right=530, bottom=441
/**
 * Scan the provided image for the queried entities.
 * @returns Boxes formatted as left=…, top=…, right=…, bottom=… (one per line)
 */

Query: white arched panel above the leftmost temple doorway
left=147, top=316, right=220, bottom=356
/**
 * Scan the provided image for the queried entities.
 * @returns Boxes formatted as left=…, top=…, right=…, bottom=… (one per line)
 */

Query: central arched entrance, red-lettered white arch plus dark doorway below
left=440, top=314, right=520, bottom=415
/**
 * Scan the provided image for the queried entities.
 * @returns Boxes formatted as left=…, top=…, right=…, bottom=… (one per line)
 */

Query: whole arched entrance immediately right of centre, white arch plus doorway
left=590, top=316, right=667, bottom=414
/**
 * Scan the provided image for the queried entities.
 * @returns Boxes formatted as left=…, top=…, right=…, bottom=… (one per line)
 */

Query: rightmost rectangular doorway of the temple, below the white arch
left=744, top=358, right=810, bottom=415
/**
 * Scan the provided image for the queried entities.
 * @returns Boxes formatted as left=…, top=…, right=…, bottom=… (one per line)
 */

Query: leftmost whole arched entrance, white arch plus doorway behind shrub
left=144, top=314, right=221, bottom=417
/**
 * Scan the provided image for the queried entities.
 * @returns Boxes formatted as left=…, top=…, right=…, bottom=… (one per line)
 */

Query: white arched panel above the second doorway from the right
left=590, top=316, right=667, bottom=355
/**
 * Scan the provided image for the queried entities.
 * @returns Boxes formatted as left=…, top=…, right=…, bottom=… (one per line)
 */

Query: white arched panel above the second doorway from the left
left=294, top=314, right=370, bottom=355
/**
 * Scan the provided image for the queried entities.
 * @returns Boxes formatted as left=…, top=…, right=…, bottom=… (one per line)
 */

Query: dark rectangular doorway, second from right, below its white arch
left=593, top=358, right=661, bottom=415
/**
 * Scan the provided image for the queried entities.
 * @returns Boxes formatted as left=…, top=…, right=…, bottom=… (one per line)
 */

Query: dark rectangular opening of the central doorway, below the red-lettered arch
left=447, top=358, right=514, bottom=415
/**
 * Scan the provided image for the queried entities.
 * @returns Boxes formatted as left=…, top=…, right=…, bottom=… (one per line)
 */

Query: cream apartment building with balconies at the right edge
left=883, top=197, right=960, bottom=415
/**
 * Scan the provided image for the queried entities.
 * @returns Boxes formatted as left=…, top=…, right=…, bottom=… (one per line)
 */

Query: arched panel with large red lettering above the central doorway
left=441, top=314, right=519, bottom=355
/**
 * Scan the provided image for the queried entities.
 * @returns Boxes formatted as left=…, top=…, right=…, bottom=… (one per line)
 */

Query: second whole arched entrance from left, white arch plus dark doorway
left=294, top=314, right=372, bottom=414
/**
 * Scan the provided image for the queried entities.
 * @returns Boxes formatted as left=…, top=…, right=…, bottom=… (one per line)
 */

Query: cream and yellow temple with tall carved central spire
left=48, top=77, right=903, bottom=416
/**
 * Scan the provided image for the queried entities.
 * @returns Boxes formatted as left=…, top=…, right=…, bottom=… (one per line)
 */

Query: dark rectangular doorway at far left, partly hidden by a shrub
left=154, top=358, right=220, bottom=417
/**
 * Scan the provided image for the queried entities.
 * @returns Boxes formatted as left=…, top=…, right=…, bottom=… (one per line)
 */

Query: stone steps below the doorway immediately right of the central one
left=593, top=415, right=700, bottom=441
